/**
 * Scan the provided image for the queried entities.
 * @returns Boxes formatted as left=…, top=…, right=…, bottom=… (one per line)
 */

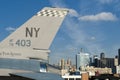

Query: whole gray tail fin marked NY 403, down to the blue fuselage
left=0, top=7, right=68, bottom=60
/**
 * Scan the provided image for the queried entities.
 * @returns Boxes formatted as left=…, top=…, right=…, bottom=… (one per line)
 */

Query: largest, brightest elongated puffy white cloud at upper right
left=79, top=12, right=117, bottom=21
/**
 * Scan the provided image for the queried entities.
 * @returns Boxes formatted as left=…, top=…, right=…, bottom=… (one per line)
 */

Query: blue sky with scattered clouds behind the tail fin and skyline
left=0, top=0, right=120, bottom=63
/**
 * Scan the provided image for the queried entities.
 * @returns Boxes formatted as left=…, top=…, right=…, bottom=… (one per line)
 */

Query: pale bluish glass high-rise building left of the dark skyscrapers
left=76, top=52, right=90, bottom=69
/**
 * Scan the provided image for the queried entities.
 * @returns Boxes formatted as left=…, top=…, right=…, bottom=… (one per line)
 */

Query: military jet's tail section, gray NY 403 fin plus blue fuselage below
left=0, top=7, right=68, bottom=79
